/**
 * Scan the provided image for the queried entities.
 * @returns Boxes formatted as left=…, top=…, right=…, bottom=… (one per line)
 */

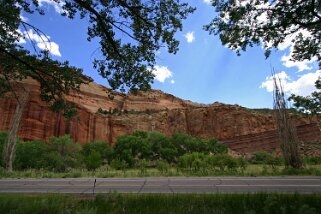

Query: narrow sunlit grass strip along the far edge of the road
left=0, top=164, right=321, bottom=178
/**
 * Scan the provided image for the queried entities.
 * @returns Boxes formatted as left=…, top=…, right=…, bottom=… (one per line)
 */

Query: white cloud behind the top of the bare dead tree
left=260, top=70, right=321, bottom=96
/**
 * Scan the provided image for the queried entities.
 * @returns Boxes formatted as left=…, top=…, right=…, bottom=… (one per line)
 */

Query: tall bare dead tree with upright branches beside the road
left=273, top=73, right=302, bottom=168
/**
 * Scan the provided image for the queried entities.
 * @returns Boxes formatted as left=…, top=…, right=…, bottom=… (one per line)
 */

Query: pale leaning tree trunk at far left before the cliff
left=3, top=90, right=29, bottom=172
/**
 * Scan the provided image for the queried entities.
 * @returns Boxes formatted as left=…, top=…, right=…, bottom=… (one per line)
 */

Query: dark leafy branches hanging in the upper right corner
left=204, top=0, right=321, bottom=66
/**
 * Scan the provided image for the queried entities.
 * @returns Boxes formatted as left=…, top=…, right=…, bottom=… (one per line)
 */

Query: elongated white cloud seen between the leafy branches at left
left=23, top=30, right=61, bottom=57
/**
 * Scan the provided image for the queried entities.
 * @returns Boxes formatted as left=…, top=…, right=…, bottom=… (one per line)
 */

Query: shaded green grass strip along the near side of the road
left=0, top=193, right=321, bottom=214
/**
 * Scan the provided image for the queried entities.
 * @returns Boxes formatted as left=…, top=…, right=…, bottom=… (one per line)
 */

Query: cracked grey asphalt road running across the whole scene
left=0, top=177, right=321, bottom=194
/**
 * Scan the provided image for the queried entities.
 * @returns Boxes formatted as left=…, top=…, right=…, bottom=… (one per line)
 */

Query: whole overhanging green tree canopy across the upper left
left=0, top=0, right=194, bottom=109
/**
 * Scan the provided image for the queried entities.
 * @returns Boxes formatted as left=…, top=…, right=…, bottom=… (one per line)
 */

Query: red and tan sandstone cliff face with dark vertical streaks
left=0, top=80, right=321, bottom=153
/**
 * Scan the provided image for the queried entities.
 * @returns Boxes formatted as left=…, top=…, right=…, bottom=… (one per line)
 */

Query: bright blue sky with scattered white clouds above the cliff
left=20, top=0, right=320, bottom=108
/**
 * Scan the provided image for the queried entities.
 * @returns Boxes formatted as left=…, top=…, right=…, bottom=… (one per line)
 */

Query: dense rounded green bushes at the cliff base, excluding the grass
left=0, top=131, right=228, bottom=172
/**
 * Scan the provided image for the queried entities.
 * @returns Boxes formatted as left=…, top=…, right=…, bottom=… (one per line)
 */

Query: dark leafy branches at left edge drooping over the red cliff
left=0, top=0, right=90, bottom=117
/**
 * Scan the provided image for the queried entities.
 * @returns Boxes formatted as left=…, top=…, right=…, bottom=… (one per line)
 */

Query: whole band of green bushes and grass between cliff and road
left=0, top=131, right=321, bottom=177
